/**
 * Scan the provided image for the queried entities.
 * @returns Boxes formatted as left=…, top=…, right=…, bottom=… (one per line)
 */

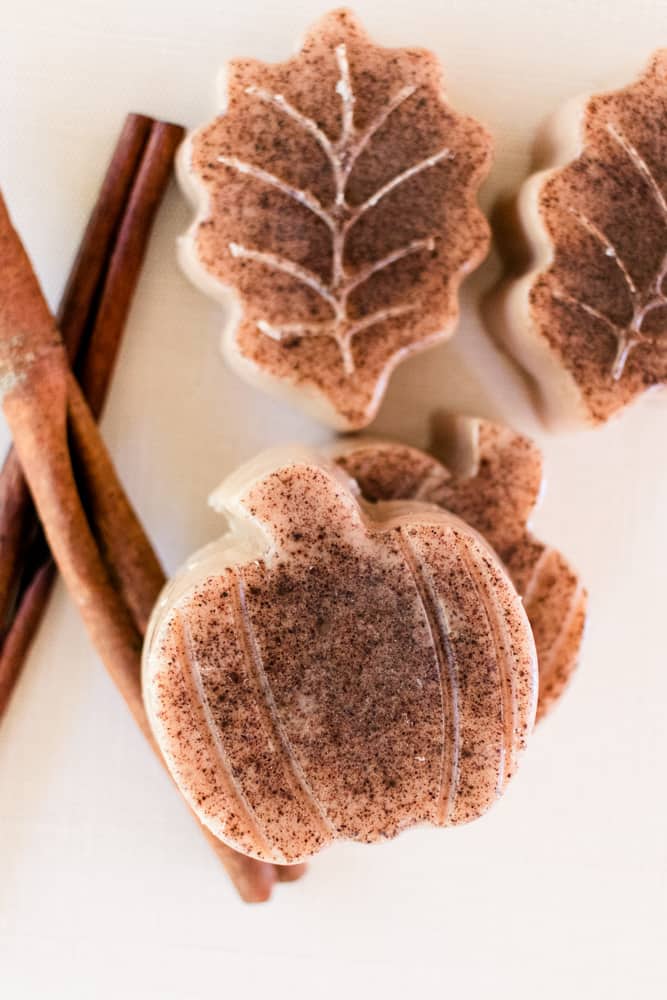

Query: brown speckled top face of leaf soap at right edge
left=529, top=49, right=667, bottom=422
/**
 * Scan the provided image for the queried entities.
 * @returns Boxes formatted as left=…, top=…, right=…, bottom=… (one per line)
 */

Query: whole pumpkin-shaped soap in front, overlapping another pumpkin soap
left=144, top=450, right=537, bottom=863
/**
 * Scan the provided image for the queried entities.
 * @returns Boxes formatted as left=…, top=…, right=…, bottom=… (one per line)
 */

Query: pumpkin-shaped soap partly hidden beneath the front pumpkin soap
left=335, top=416, right=587, bottom=720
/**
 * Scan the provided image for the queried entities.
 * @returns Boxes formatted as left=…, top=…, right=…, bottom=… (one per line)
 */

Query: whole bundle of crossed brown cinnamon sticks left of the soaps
left=0, top=115, right=304, bottom=901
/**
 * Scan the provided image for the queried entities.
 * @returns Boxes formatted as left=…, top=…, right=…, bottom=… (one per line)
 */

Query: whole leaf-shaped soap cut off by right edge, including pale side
left=487, top=49, right=667, bottom=424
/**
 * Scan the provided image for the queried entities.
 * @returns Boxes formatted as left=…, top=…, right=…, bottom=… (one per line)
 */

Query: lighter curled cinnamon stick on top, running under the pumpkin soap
left=0, top=158, right=303, bottom=901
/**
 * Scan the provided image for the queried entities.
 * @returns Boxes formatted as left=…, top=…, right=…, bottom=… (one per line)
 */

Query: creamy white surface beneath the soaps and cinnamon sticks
left=0, top=0, right=667, bottom=1000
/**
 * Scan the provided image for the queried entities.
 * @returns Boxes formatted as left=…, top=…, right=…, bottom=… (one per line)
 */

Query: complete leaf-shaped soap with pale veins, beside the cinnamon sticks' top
left=180, top=10, right=491, bottom=429
